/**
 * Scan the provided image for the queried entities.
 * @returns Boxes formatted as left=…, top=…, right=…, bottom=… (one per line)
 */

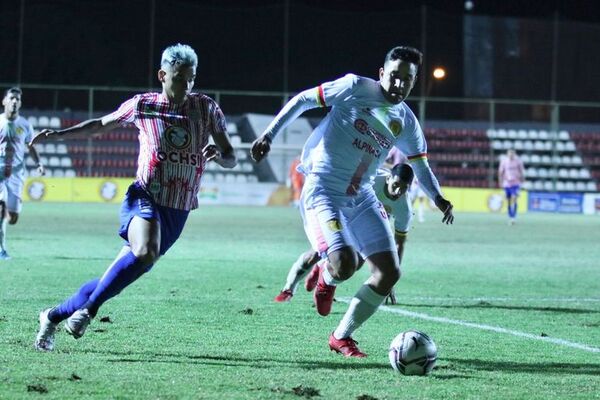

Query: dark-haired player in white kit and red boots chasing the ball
left=251, top=46, right=454, bottom=357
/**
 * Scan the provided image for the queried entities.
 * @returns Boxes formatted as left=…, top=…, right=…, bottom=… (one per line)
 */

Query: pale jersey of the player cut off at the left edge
left=0, top=113, right=33, bottom=179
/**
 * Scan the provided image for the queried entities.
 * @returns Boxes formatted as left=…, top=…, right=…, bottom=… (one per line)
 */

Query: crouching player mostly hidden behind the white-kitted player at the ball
left=274, top=162, right=414, bottom=304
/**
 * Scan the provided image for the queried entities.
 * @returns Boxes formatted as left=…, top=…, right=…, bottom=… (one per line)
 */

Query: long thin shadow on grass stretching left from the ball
left=81, top=350, right=390, bottom=370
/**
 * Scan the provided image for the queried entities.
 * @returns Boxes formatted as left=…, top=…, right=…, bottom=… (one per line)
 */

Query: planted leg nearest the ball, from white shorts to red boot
left=329, top=197, right=400, bottom=357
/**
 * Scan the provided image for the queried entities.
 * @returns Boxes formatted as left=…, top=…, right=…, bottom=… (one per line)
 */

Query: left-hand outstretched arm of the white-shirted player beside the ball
left=250, top=86, right=322, bottom=162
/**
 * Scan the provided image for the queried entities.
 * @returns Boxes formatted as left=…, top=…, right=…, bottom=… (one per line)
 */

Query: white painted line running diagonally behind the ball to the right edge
left=338, top=298, right=600, bottom=353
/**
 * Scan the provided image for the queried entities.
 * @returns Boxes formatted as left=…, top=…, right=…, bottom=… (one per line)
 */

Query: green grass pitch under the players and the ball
left=0, top=203, right=600, bottom=400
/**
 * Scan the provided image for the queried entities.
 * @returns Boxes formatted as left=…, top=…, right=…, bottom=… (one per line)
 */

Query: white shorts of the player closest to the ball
left=301, top=180, right=396, bottom=259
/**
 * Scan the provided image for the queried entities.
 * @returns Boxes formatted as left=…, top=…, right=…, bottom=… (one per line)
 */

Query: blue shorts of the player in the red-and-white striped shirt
left=119, top=183, right=190, bottom=256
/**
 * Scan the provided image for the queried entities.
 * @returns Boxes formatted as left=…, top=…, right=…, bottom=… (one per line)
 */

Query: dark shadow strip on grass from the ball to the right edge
left=444, top=357, right=600, bottom=376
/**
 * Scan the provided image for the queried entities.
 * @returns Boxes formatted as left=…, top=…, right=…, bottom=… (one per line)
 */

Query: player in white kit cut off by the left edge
left=0, top=87, right=45, bottom=260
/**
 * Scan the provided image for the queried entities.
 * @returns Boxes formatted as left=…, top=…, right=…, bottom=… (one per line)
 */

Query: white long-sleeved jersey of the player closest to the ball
left=267, top=74, right=439, bottom=202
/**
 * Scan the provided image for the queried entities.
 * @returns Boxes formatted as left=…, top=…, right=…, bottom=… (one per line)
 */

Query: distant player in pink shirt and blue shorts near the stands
left=498, top=149, right=525, bottom=225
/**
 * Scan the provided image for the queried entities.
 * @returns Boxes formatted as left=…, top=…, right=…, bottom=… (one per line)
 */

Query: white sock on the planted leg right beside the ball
left=333, top=284, right=385, bottom=339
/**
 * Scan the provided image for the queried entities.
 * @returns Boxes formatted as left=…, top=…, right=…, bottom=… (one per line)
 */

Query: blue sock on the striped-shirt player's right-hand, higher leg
left=81, top=251, right=151, bottom=316
